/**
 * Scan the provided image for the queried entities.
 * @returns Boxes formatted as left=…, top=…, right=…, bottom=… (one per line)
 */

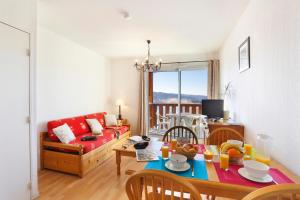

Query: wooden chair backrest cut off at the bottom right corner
left=242, top=184, right=300, bottom=200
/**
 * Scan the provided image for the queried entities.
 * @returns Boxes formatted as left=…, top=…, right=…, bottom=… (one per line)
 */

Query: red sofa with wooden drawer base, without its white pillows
left=41, top=112, right=131, bottom=177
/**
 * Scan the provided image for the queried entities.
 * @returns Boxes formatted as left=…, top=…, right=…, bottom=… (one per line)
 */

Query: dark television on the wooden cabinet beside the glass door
left=202, top=99, right=224, bottom=119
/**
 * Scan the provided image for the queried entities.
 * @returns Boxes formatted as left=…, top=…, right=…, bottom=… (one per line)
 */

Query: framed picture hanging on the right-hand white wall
left=239, top=37, right=250, bottom=72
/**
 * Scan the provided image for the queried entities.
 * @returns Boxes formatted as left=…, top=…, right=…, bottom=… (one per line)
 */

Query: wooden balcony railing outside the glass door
left=149, top=103, right=202, bottom=127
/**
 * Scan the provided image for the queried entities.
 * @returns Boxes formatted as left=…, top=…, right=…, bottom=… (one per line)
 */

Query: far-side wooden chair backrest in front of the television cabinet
left=206, top=127, right=244, bottom=145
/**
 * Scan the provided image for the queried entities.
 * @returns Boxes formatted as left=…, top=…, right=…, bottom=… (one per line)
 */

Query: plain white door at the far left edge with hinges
left=0, top=23, right=30, bottom=200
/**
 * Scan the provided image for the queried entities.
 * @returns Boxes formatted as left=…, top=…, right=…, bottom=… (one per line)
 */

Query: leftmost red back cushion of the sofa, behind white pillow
left=48, top=116, right=91, bottom=141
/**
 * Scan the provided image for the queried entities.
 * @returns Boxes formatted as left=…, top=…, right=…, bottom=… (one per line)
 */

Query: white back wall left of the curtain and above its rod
left=111, top=53, right=217, bottom=134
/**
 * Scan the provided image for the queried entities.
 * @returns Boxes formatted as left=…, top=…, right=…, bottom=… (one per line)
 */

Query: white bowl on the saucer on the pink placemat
left=244, top=160, right=270, bottom=178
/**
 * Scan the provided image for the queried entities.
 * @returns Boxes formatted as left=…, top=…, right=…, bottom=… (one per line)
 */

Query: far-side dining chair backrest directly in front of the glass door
left=162, top=126, right=198, bottom=144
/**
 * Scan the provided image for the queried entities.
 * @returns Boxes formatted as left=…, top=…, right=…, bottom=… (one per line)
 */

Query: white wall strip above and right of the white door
left=0, top=0, right=38, bottom=197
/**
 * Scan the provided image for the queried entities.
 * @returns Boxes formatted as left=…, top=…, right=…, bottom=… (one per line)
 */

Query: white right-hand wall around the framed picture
left=220, top=0, right=300, bottom=175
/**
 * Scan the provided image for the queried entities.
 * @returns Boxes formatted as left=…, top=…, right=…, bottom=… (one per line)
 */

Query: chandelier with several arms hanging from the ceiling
left=134, top=40, right=162, bottom=72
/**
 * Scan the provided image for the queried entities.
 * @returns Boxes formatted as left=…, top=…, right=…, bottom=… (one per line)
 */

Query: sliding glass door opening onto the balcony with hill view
left=149, top=66, right=208, bottom=135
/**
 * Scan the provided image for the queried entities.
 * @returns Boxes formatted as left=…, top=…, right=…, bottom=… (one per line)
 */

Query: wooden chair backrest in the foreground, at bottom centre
left=126, top=170, right=201, bottom=200
